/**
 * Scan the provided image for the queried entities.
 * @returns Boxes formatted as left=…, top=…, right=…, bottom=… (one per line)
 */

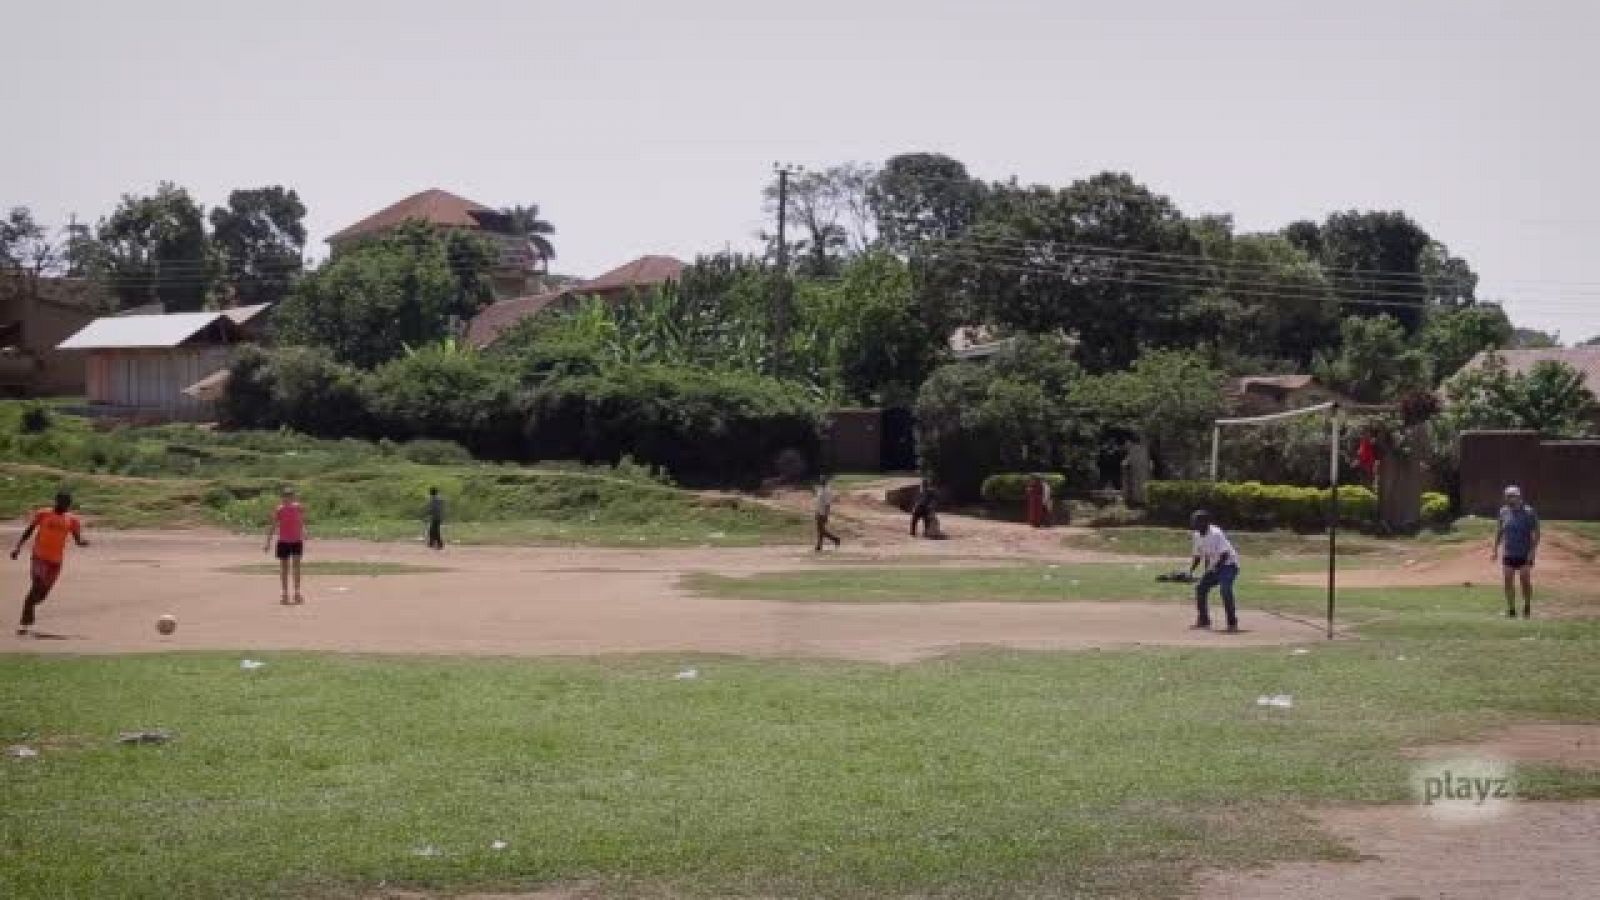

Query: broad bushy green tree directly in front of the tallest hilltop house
left=274, top=223, right=496, bottom=368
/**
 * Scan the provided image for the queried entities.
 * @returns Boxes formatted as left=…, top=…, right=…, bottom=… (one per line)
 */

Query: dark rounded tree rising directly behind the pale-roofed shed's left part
left=96, top=181, right=216, bottom=312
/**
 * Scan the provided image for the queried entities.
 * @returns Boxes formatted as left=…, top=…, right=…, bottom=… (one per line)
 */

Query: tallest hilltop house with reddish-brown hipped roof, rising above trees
left=328, top=187, right=539, bottom=298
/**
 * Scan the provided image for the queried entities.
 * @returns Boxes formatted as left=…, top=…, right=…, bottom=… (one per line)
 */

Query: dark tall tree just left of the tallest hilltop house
left=211, top=186, right=306, bottom=306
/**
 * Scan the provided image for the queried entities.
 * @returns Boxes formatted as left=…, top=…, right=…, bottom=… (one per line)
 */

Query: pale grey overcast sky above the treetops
left=0, top=0, right=1600, bottom=340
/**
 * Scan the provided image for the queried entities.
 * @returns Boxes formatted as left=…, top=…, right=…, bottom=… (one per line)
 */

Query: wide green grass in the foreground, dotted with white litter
left=0, top=636, right=1600, bottom=898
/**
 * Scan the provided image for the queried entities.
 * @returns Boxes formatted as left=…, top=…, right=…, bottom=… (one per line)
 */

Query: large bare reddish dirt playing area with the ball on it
left=0, top=532, right=1317, bottom=663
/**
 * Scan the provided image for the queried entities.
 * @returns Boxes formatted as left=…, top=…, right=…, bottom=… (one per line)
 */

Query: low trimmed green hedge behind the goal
left=1147, top=482, right=1378, bottom=532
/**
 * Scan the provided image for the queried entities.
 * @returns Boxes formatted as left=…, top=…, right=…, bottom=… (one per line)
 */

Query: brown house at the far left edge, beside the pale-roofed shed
left=0, top=277, right=110, bottom=397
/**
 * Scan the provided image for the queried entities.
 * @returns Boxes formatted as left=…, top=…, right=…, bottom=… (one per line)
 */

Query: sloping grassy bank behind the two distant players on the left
left=0, top=404, right=805, bottom=546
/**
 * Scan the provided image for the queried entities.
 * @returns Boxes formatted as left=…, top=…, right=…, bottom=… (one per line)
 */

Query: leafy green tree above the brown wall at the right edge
left=1443, top=354, right=1595, bottom=437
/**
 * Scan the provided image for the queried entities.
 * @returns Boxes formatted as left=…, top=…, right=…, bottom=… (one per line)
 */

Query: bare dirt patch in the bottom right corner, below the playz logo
left=1194, top=802, right=1600, bottom=900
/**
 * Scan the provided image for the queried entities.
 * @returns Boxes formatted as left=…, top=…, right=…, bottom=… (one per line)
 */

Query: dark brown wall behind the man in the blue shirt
left=1461, top=431, right=1600, bottom=519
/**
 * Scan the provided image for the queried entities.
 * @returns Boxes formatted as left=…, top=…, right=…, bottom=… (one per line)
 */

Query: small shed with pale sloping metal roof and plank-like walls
left=59, top=311, right=248, bottom=420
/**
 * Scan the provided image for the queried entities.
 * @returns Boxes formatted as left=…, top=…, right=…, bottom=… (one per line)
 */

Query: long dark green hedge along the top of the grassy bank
left=218, top=348, right=819, bottom=484
